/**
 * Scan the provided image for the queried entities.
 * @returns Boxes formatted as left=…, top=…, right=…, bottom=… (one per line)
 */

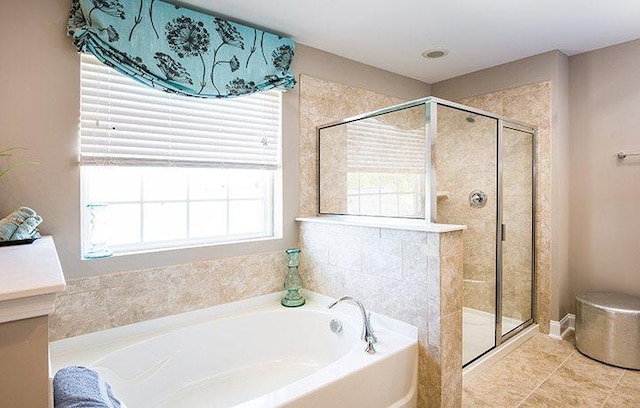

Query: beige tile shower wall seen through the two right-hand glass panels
left=435, top=99, right=532, bottom=320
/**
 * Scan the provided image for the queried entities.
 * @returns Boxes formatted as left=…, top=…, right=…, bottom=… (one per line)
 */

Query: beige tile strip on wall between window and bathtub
left=49, top=251, right=287, bottom=341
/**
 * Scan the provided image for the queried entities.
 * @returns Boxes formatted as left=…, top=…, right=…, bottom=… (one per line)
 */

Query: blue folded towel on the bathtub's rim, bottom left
left=53, top=366, right=126, bottom=408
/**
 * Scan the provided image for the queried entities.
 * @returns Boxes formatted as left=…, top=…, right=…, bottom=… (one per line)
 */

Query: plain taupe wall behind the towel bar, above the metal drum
left=569, top=40, right=640, bottom=308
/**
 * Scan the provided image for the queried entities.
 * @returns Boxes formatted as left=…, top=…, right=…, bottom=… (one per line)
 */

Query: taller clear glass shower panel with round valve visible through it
left=433, top=104, right=498, bottom=364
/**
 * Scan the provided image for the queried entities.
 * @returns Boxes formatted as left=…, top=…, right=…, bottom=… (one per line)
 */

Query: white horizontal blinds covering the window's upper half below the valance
left=80, top=54, right=281, bottom=169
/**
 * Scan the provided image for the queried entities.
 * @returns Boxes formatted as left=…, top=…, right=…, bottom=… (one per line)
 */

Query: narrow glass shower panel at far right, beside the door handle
left=497, top=124, right=535, bottom=337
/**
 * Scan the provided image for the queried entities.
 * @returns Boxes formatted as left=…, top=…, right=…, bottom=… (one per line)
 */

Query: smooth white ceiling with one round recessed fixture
left=181, top=0, right=640, bottom=83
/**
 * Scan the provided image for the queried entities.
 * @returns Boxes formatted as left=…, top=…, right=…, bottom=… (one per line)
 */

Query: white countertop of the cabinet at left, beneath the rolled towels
left=0, top=236, right=66, bottom=323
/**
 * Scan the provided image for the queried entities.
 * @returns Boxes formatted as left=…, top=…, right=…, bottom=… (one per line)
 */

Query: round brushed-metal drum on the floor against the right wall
left=576, top=292, right=640, bottom=370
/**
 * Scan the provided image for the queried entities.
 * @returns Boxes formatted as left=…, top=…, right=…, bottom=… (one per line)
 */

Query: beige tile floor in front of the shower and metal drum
left=462, top=334, right=640, bottom=408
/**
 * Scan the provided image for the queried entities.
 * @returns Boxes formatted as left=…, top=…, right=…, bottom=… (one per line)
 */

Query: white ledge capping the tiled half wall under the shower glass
left=296, top=215, right=467, bottom=233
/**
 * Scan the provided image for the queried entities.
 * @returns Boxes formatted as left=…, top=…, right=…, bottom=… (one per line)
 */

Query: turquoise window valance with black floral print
left=68, top=0, right=295, bottom=98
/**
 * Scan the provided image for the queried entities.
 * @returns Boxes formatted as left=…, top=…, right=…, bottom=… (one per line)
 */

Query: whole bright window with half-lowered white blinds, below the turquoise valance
left=80, top=54, right=282, bottom=258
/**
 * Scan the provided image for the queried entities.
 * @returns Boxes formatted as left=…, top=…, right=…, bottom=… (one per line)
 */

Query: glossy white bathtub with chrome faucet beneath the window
left=50, top=292, right=418, bottom=408
